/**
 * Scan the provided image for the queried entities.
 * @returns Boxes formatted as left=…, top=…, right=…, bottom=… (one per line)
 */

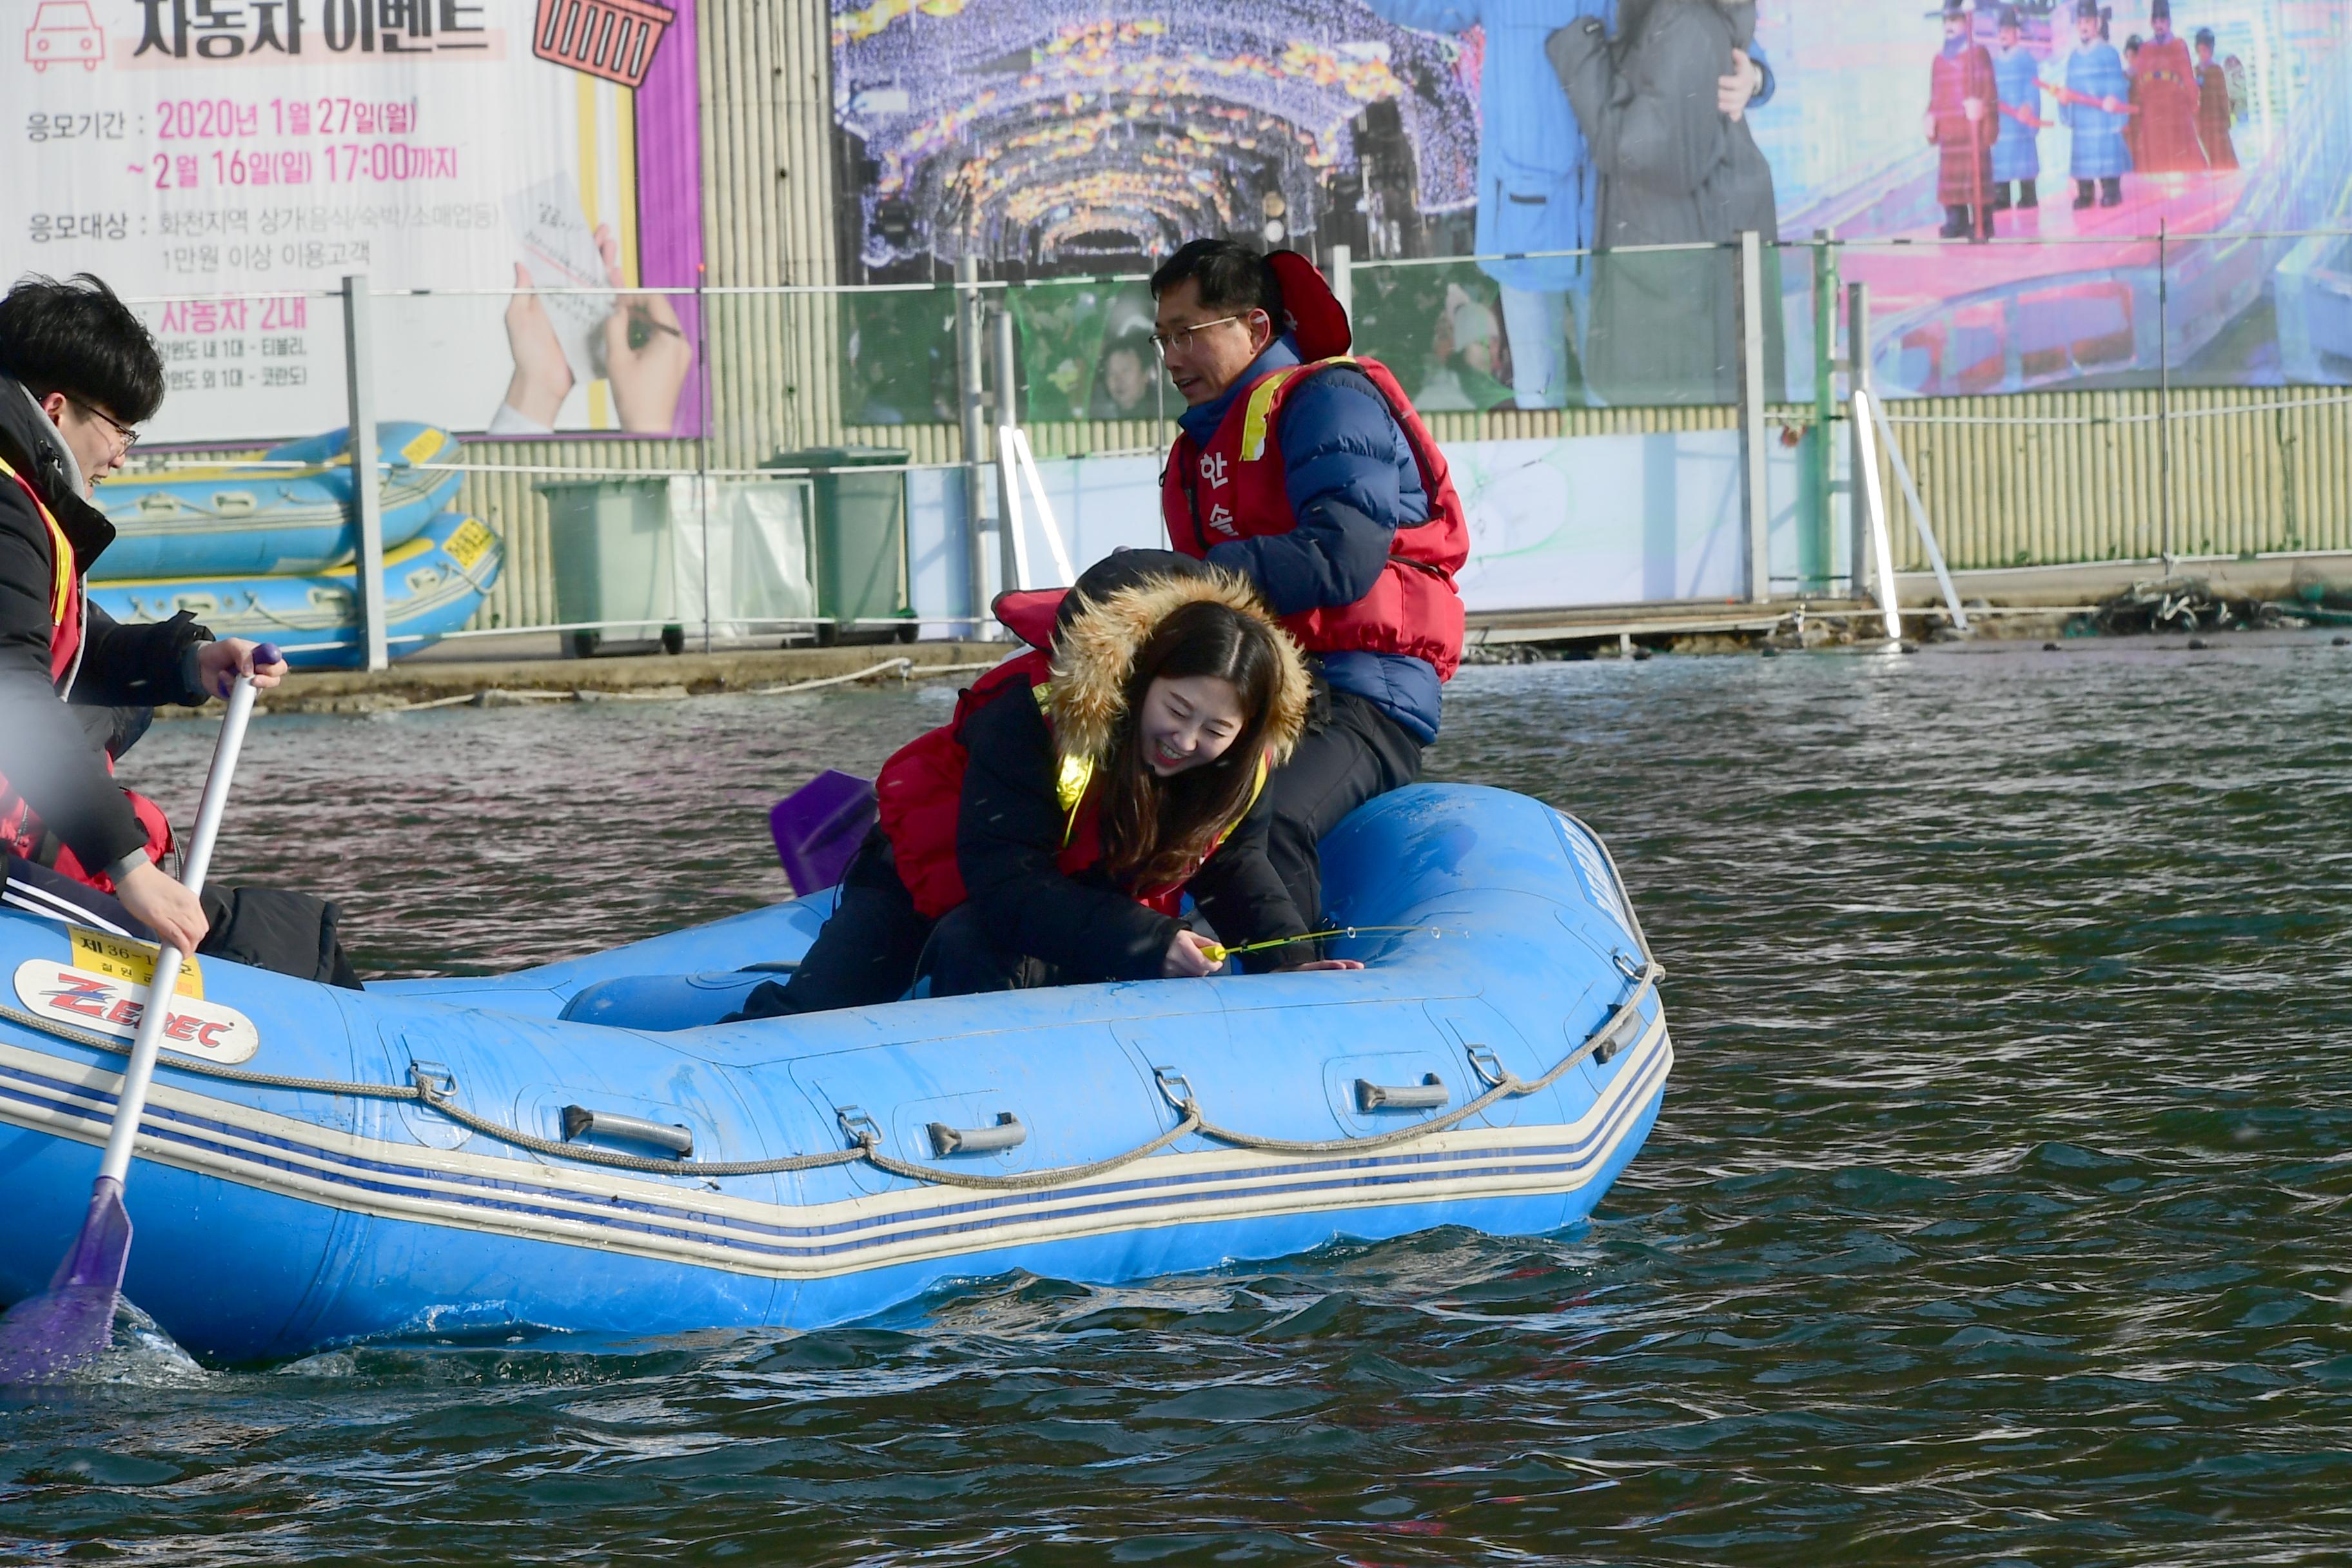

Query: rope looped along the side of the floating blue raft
left=0, top=959, right=1665, bottom=1192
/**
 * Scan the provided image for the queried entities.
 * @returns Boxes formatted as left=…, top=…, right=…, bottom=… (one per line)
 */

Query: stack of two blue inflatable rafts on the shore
left=90, top=423, right=505, bottom=665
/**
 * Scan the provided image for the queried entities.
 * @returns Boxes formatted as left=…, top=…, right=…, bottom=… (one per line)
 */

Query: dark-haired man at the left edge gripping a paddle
left=0, top=275, right=284, bottom=952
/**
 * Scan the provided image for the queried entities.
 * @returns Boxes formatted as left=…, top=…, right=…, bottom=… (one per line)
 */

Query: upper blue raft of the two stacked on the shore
left=92, top=421, right=464, bottom=583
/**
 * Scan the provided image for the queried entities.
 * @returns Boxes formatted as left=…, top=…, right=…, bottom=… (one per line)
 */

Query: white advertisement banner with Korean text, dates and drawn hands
left=0, top=0, right=701, bottom=440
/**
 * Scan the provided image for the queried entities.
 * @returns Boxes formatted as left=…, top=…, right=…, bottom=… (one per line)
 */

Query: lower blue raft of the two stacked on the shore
left=90, top=513, right=505, bottom=668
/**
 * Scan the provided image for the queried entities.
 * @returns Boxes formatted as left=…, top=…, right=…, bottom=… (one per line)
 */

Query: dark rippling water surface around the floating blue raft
left=0, top=640, right=2352, bottom=1565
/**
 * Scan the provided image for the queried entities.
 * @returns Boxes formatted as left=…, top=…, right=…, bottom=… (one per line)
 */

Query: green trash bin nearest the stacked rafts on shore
left=536, top=480, right=687, bottom=658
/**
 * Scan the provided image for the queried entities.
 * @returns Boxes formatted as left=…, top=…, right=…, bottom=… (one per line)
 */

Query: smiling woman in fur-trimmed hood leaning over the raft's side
left=741, top=550, right=1355, bottom=1018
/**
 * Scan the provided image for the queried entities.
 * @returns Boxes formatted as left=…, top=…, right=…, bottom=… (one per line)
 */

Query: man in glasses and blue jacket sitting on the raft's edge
left=1153, top=240, right=1470, bottom=921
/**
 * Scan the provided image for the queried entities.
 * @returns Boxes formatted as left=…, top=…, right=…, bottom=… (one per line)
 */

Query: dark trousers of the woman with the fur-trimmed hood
left=727, top=827, right=1068, bottom=1023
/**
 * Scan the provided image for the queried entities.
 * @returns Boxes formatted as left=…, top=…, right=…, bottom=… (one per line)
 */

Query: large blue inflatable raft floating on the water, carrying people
left=0, top=785, right=1674, bottom=1361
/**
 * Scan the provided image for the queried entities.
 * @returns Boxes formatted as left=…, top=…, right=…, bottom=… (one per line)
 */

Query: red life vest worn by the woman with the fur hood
left=875, top=616, right=1268, bottom=919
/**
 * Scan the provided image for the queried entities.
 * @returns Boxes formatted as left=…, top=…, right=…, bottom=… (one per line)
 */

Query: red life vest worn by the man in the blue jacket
left=1159, top=355, right=1470, bottom=680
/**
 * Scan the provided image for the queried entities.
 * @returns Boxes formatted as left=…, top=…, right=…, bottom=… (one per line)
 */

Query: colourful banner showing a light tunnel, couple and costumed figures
left=832, top=0, right=2352, bottom=404
